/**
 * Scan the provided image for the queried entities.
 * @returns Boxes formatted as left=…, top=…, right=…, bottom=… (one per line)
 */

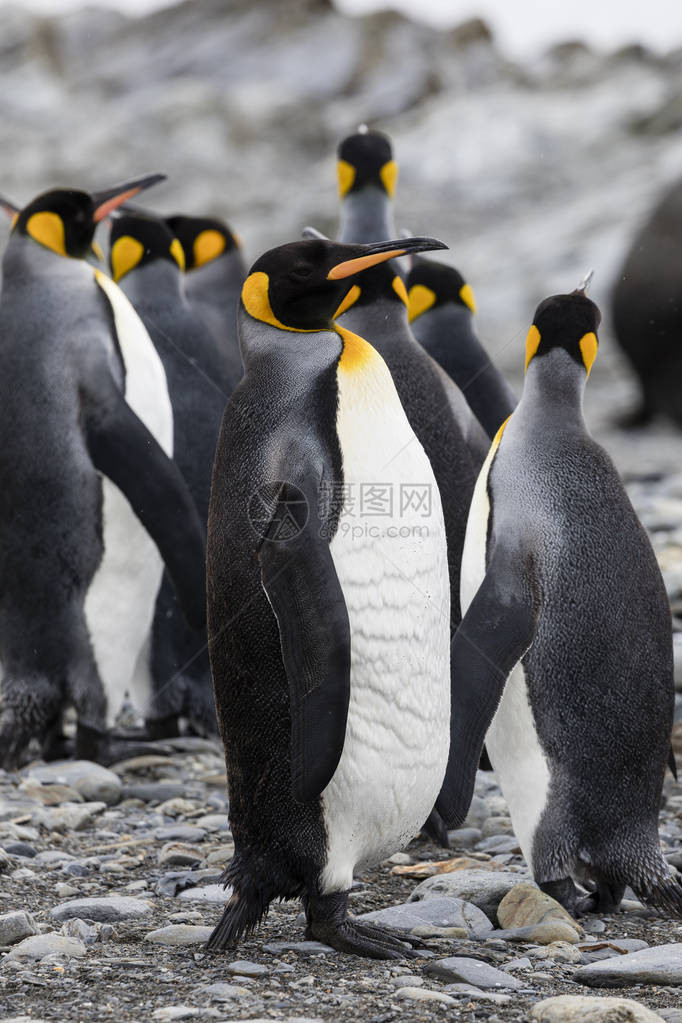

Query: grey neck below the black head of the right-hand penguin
left=518, top=348, right=587, bottom=430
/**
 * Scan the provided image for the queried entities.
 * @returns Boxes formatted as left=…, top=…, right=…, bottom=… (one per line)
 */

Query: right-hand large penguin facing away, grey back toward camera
left=444, top=276, right=682, bottom=916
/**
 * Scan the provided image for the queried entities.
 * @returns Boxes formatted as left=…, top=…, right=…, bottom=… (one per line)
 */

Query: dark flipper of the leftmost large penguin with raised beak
left=86, top=382, right=206, bottom=628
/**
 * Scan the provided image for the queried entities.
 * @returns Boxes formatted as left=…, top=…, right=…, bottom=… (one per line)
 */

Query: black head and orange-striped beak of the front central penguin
left=241, top=238, right=447, bottom=331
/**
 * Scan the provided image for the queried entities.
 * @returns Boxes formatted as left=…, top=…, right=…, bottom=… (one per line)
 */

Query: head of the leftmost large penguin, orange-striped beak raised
left=12, top=174, right=166, bottom=259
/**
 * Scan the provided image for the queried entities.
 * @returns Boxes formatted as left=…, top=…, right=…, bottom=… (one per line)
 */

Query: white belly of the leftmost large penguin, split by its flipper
left=85, top=272, right=173, bottom=725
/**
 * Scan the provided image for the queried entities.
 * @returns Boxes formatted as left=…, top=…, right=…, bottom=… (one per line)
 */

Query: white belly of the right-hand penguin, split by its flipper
left=460, top=429, right=549, bottom=869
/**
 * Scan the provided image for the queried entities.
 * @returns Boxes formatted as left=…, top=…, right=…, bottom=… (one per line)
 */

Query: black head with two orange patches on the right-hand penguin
left=526, top=290, right=601, bottom=376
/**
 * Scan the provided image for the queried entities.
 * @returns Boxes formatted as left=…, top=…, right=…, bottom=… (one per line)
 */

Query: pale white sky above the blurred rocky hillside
left=0, top=0, right=682, bottom=57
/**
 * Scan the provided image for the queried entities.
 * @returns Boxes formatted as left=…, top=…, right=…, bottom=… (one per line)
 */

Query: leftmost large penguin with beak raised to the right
left=0, top=175, right=204, bottom=765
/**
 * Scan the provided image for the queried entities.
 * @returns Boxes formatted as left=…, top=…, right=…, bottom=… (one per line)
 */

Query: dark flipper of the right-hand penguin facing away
left=436, top=551, right=537, bottom=828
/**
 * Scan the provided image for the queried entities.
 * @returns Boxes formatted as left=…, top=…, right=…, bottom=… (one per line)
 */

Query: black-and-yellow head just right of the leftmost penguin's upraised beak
left=109, top=210, right=185, bottom=281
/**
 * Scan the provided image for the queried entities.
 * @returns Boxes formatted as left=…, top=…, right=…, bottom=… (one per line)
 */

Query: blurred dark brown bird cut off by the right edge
left=612, top=181, right=682, bottom=426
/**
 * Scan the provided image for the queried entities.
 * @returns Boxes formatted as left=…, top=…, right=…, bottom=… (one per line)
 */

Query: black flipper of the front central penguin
left=259, top=455, right=351, bottom=803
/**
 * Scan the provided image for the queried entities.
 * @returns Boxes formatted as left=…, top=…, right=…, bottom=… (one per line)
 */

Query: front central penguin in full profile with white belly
left=207, top=238, right=488, bottom=959
